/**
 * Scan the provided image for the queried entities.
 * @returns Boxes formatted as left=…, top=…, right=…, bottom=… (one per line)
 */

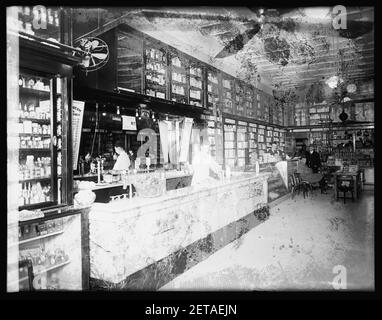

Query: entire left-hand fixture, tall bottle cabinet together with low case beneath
left=7, top=19, right=84, bottom=292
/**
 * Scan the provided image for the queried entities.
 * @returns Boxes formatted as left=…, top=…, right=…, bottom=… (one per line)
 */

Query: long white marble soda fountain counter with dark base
left=89, top=173, right=269, bottom=289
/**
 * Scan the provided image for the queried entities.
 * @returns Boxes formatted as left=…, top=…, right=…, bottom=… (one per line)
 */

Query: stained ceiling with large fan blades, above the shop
left=73, top=7, right=374, bottom=94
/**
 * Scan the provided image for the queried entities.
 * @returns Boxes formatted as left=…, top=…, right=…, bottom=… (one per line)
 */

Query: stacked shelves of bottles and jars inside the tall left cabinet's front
left=18, top=73, right=54, bottom=209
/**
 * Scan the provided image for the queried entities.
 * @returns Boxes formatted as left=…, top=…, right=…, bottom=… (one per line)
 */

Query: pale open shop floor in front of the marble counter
left=160, top=187, right=374, bottom=290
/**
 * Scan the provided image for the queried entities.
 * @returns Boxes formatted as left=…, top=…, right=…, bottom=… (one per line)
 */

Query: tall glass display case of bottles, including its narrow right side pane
left=18, top=70, right=62, bottom=210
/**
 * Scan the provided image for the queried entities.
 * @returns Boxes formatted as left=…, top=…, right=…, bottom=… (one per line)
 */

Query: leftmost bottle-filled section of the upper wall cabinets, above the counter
left=144, top=44, right=167, bottom=99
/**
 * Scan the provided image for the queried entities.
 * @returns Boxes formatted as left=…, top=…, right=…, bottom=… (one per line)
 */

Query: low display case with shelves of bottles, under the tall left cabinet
left=18, top=215, right=82, bottom=291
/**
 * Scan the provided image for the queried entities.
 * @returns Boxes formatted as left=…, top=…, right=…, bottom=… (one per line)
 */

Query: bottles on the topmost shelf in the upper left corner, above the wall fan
left=11, top=6, right=61, bottom=42
